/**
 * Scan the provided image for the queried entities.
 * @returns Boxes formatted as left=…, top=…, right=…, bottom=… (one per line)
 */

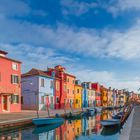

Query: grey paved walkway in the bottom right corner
left=129, top=106, right=140, bottom=140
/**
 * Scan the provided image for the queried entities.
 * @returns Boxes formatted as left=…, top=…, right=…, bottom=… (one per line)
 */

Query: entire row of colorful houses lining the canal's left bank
left=0, top=50, right=138, bottom=112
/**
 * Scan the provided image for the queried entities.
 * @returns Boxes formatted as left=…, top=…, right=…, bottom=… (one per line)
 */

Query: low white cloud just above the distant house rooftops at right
left=73, top=69, right=140, bottom=92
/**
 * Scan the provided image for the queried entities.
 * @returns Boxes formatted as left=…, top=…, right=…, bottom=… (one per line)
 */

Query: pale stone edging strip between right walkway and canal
left=119, top=109, right=135, bottom=140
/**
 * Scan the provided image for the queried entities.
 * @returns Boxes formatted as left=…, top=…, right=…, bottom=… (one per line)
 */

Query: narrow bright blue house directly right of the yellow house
left=82, top=82, right=88, bottom=107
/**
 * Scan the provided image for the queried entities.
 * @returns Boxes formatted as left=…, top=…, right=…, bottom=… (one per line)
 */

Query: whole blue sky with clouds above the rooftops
left=0, top=0, right=140, bottom=91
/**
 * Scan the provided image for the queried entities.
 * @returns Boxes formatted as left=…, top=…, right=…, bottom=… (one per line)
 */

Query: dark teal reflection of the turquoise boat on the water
left=32, top=122, right=63, bottom=134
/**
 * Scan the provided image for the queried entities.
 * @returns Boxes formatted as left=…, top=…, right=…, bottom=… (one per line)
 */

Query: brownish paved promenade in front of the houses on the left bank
left=0, top=109, right=85, bottom=129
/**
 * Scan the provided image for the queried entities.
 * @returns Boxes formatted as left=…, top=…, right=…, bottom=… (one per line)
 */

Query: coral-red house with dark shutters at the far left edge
left=0, top=50, right=21, bottom=113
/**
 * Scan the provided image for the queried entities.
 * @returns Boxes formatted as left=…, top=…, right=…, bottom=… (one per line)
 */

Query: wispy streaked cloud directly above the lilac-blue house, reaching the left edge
left=0, top=44, right=74, bottom=72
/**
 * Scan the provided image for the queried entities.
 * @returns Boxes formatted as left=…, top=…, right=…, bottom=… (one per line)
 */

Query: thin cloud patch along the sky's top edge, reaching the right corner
left=61, top=0, right=140, bottom=17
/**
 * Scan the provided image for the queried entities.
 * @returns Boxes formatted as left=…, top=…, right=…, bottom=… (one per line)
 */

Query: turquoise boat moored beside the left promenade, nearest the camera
left=32, top=118, right=64, bottom=126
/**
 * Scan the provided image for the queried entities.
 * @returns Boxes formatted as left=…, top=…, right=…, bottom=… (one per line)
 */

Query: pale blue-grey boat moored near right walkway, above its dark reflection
left=101, top=119, right=120, bottom=127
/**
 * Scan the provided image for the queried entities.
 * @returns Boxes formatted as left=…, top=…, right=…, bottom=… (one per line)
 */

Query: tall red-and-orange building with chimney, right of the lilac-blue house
left=47, top=65, right=75, bottom=109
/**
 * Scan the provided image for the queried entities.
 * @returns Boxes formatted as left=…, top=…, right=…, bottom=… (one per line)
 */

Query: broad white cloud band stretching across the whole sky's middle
left=0, top=15, right=140, bottom=60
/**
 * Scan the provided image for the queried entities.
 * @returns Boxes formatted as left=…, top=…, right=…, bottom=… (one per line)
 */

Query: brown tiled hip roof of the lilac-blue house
left=22, top=68, right=52, bottom=78
